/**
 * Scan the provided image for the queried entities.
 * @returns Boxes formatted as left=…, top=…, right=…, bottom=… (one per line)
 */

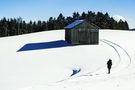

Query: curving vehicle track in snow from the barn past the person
left=56, top=39, right=131, bottom=83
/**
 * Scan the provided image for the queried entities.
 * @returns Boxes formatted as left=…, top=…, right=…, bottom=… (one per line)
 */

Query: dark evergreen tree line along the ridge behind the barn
left=0, top=11, right=129, bottom=37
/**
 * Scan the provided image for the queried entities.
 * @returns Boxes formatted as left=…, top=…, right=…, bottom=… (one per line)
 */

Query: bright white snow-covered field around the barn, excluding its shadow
left=0, top=30, right=135, bottom=90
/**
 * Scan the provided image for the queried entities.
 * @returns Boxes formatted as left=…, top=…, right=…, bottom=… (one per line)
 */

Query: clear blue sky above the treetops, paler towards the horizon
left=0, top=0, right=135, bottom=28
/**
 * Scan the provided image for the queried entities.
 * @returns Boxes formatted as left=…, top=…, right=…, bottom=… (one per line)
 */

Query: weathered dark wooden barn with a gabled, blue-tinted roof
left=65, top=20, right=99, bottom=45
